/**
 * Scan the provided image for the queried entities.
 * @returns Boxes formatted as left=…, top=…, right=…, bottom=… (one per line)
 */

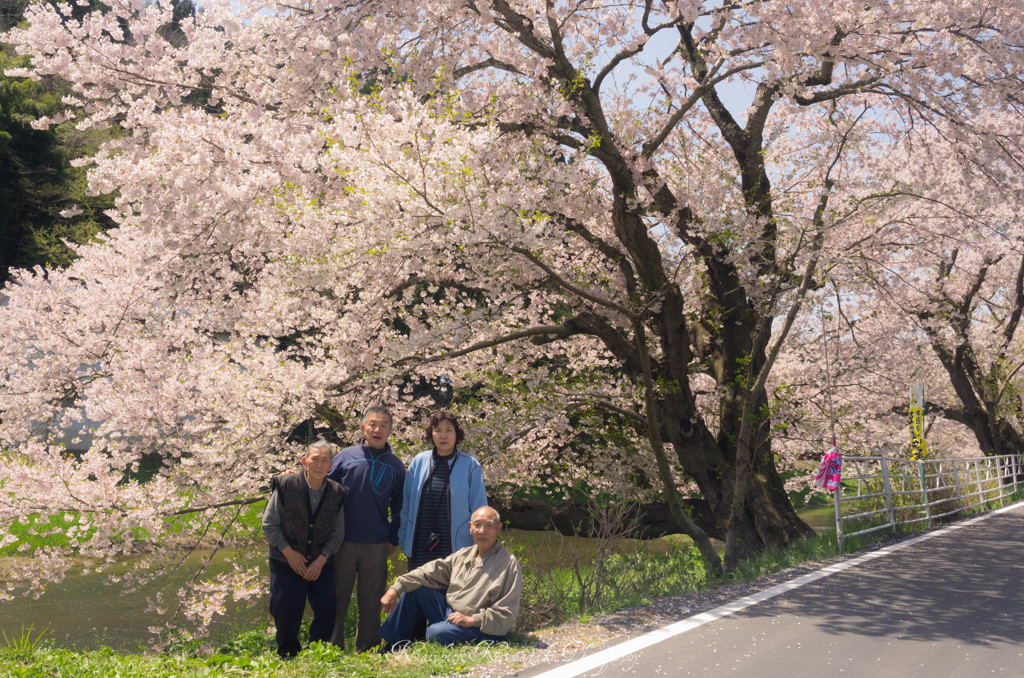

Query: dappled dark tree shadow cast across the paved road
left=740, top=512, right=1024, bottom=645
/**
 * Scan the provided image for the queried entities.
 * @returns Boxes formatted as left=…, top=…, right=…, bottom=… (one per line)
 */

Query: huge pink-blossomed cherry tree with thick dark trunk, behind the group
left=0, top=0, right=1022, bottom=622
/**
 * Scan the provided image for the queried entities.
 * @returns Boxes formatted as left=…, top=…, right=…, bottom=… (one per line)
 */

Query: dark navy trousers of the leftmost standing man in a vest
left=270, top=558, right=335, bottom=658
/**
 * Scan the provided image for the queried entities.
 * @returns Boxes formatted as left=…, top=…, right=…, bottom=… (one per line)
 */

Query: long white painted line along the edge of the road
left=532, top=502, right=1024, bottom=678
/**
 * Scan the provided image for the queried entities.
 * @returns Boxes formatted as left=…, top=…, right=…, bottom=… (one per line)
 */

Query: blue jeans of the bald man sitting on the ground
left=377, top=587, right=505, bottom=645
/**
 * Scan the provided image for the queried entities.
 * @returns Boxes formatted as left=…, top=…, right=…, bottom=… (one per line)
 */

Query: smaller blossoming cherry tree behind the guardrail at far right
left=775, top=109, right=1024, bottom=481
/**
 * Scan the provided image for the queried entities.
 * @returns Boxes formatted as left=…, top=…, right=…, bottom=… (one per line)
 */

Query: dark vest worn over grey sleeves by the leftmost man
left=271, top=473, right=345, bottom=562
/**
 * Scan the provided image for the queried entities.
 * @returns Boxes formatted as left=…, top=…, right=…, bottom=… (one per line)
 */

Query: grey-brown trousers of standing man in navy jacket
left=331, top=542, right=388, bottom=652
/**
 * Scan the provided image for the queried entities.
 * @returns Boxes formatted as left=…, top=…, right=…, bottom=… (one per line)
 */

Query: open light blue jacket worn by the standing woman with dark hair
left=398, top=450, right=487, bottom=556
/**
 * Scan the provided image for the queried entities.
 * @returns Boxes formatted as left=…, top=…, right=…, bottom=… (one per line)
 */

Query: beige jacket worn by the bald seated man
left=391, top=542, right=522, bottom=636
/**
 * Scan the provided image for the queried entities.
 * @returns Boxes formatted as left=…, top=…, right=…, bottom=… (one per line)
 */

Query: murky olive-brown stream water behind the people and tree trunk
left=0, top=506, right=835, bottom=650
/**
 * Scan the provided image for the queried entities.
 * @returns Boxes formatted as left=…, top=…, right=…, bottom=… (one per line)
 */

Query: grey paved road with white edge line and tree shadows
left=519, top=504, right=1024, bottom=678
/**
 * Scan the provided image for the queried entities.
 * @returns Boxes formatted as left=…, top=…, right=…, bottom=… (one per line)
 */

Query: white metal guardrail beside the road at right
left=834, top=455, right=1024, bottom=553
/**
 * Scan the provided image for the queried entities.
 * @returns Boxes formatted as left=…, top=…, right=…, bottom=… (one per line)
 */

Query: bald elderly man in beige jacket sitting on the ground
left=378, top=506, right=522, bottom=649
